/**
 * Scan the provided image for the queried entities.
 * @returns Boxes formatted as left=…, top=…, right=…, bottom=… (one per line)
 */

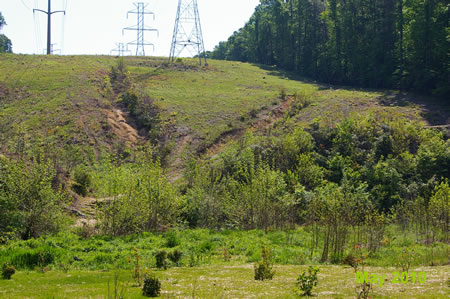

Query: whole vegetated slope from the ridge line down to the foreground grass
left=0, top=55, right=450, bottom=297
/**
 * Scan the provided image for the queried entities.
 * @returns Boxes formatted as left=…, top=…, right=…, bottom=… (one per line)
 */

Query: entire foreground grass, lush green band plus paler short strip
left=0, top=227, right=449, bottom=298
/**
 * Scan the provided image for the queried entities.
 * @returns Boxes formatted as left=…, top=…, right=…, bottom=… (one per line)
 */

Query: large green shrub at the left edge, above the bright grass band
left=0, top=155, right=64, bottom=239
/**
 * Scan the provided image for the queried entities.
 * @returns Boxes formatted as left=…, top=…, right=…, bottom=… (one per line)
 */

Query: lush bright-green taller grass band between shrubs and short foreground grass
left=0, top=226, right=449, bottom=270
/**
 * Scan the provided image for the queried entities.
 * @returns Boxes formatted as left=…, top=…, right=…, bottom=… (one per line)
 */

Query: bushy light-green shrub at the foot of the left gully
left=99, top=154, right=182, bottom=236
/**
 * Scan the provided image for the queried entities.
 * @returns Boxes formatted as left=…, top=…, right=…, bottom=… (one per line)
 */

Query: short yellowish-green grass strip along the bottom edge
left=0, top=264, right=450, bottom=298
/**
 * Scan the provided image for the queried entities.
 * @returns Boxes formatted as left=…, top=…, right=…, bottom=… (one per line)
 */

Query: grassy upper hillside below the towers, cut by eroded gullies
left=0, top=55, right=449, bottom=177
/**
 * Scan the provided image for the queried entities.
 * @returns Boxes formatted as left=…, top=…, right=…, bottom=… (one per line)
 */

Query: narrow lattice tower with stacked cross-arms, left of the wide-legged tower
left=123, top=2, right=159, bottom=56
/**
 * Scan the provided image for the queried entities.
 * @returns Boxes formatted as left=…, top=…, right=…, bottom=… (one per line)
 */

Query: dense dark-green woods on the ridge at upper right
left=211, top=0, right=450, bottom=96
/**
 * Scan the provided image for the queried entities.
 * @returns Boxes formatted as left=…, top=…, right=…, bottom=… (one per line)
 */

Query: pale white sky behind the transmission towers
left=0, top=0, right=259, bottom=56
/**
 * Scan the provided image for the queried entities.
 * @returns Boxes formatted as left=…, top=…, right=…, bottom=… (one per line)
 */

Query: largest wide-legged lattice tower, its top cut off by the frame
left=169, top=0, right=208, bottom=65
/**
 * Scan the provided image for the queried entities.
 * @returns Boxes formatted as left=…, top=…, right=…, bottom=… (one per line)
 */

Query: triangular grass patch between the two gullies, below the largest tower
left=130, top=59, right=318, bottom=142
